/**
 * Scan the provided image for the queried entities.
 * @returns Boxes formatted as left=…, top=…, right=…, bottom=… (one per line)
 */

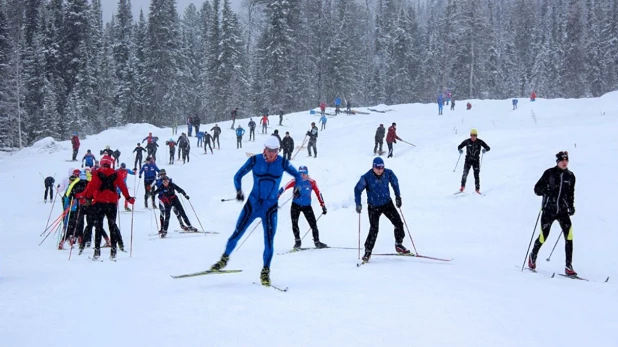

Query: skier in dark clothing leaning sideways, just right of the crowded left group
left=153, top=176, right=197, bottom=238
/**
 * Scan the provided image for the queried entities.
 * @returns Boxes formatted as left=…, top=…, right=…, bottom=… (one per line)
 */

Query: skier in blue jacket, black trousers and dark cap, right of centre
left=354, top=157, right=410, bottom=262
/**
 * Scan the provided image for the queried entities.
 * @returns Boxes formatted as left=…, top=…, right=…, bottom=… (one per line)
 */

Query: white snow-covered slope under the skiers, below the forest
left=0, top=92, right=618, bottom=347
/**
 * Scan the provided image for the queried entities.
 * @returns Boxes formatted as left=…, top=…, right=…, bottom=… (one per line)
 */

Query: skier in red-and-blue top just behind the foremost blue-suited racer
left=278, top=166, right=328, bottom=249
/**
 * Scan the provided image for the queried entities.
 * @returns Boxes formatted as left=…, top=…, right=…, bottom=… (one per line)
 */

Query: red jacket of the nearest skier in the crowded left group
left=76, top=167, right=130, bottom=204
